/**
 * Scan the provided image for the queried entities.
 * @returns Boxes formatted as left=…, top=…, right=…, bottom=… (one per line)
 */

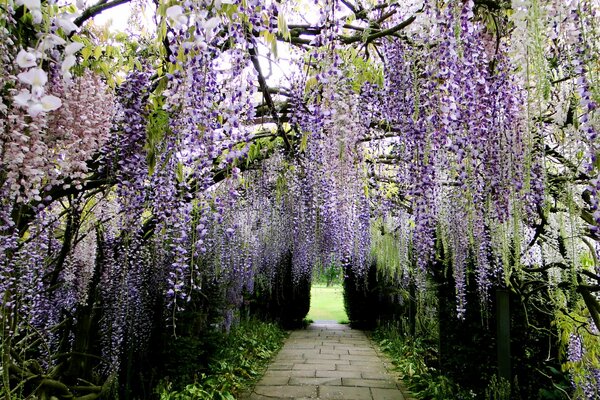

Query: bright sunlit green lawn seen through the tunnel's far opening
left=306, top=285, right=348, bottom=322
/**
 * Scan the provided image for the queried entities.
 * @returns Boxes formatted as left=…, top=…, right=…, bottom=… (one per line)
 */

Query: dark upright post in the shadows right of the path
left=496, top=289, right=512, bottom=383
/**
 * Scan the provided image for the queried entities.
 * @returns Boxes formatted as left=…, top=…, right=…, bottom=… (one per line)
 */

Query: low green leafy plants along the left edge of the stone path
left=155, top=319, right=286, bottom=400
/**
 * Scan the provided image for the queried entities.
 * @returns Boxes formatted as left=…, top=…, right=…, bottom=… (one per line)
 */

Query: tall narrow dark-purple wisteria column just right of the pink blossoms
left=96, top=71, right=162, bottom=373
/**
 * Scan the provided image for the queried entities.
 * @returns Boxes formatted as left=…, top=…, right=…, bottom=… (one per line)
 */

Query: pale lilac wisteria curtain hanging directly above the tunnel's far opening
left=292, top=79, right=370, bottom=274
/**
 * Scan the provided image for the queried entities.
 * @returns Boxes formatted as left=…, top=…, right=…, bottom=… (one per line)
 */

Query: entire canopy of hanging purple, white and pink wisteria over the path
left=0, top=0, right=600, bottom=398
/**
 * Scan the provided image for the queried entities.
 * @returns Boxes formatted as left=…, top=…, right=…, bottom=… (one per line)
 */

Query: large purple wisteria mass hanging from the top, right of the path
left=371, top=1, right=537, bottom=315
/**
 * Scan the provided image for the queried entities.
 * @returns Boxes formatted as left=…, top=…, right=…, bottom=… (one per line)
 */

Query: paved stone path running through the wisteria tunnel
left=245, top=321, right=413, bottom=400
